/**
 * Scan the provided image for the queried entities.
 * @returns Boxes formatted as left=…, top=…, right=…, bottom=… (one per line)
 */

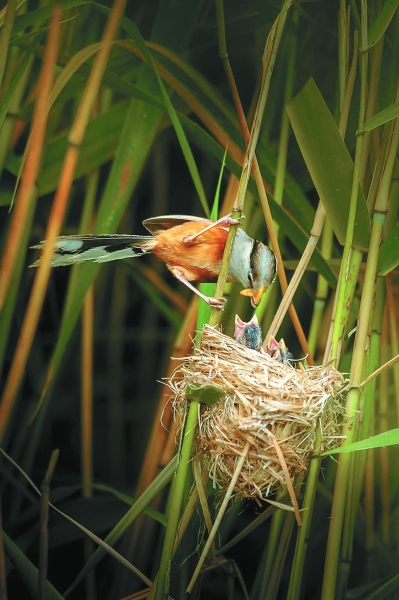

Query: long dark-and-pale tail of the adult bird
left=31, top=234, right=154, bottom=267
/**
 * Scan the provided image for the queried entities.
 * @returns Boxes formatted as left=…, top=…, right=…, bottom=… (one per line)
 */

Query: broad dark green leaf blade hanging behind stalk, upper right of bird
left=287, top=79, right=370, bottom=250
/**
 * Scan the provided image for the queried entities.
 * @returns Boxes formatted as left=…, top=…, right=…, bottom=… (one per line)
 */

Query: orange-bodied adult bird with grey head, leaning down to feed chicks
left=32, top=215, right=277, bottom=310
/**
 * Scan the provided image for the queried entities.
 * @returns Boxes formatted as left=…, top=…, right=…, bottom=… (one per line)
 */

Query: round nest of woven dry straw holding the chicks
left=168, top=325, right=344, bottom=499
